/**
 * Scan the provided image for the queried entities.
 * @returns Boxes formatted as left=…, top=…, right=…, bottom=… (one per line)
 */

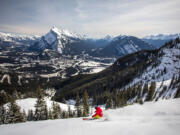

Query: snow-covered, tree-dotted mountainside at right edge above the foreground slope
left=128, top=41, right=180, bottom=100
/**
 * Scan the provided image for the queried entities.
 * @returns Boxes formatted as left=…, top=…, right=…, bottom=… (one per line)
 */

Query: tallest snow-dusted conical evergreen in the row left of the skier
left=34, top=87, right=48, bottom=120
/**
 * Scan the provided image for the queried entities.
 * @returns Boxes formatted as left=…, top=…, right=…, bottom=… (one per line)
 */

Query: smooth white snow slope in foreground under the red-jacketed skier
left=0, top=99, right=180, bottom=135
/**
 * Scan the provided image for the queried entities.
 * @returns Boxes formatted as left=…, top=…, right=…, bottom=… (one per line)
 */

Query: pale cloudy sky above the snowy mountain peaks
left=0, top=0, right=180, bottom=37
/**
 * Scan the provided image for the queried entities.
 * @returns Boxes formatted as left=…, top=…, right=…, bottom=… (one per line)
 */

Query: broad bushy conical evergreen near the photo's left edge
left=7, top=99, right=24, bottom=123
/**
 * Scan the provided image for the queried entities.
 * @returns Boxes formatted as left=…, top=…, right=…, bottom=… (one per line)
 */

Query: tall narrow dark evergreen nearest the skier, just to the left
left=83, top=90, right=89, bottom=116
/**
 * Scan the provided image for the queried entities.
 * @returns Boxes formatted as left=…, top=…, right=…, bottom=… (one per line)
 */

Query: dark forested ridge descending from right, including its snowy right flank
left=55, top=39, right=180, bottom=102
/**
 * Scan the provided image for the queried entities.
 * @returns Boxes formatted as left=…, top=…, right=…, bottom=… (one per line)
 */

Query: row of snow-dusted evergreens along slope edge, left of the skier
left=0, top=87, right=90, bottom=124
